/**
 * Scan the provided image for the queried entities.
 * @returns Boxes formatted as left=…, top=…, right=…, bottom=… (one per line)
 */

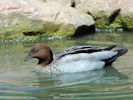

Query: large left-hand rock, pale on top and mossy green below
left=0, top=0, right=94, bottom=39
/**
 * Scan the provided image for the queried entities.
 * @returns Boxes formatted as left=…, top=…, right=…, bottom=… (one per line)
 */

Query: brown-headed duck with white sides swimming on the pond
left=25, top=43, right=128, bottom=73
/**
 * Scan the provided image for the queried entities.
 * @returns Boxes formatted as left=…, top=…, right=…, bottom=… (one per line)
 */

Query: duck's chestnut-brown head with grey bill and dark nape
left=25, top=43, right=53, bottom=67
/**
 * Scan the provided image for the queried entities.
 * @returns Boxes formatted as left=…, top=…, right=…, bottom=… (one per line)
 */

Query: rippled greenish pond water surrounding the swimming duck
left=0, top=33, right=133, bottom=100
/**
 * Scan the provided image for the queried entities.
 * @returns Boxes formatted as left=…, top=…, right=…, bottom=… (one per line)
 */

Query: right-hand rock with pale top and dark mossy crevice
left=75, top=0, right=133, bottom=31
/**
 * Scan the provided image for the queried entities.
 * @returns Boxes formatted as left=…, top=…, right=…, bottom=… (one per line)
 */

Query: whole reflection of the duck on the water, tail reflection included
left=36, top=67, right=128, bottom=87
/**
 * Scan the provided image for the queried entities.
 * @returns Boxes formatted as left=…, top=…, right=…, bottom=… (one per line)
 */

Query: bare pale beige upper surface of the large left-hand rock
left=0, top=0, right=94, bottom=27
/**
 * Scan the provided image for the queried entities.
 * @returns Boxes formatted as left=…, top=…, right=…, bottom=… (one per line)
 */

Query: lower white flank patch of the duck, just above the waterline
left=58, top=60, right=105, bottom=73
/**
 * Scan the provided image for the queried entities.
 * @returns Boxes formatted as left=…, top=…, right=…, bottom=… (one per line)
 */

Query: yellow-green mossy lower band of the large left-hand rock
left=0, top=13, right=75, bottom=41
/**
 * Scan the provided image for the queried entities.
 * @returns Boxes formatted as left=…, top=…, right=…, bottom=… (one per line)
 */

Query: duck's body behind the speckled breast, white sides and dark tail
left=54, top=46, right=127, bottom=72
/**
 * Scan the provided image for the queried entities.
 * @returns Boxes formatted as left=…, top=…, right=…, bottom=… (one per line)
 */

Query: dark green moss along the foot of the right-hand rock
left=95, top=12, right=133, bottom=31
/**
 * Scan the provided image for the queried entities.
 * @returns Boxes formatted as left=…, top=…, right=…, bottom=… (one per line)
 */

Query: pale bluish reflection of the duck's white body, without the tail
left=37, top=70, right=105, bottom=87
